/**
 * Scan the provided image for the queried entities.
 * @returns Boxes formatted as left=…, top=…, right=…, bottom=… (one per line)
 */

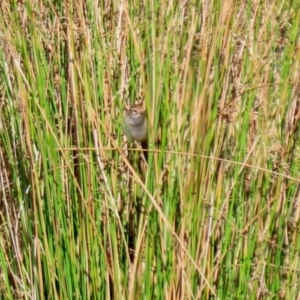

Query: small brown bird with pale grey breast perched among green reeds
left=123, top=104, right=148, bottom=159
